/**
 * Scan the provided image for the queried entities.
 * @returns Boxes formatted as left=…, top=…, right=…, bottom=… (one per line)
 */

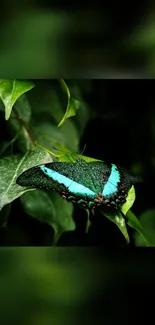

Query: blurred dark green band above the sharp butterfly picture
left=0, top=0, right=155, bottom=78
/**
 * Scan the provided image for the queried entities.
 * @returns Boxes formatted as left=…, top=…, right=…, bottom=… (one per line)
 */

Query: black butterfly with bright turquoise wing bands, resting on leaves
left=17, top=158, right=141, bottom=208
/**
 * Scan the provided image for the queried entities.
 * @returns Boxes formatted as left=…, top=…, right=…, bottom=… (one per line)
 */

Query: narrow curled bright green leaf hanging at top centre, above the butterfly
left=58, top=79, right=80, bottom=127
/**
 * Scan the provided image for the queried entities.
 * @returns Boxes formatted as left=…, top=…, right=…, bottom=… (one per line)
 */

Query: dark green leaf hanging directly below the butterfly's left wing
left=21, top=189, right=75, bottom=243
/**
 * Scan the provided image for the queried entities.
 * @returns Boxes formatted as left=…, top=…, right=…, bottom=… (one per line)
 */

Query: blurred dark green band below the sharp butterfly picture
left=0, top=248, right=154, bottom=325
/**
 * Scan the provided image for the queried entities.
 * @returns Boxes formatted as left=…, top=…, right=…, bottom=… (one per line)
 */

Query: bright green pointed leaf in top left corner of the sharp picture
left=0, top=79, right=34, bottom=120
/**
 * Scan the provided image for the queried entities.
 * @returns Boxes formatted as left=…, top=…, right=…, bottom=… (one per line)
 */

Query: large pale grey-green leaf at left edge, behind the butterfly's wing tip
left=0, top=148, right=52, bottom=210
